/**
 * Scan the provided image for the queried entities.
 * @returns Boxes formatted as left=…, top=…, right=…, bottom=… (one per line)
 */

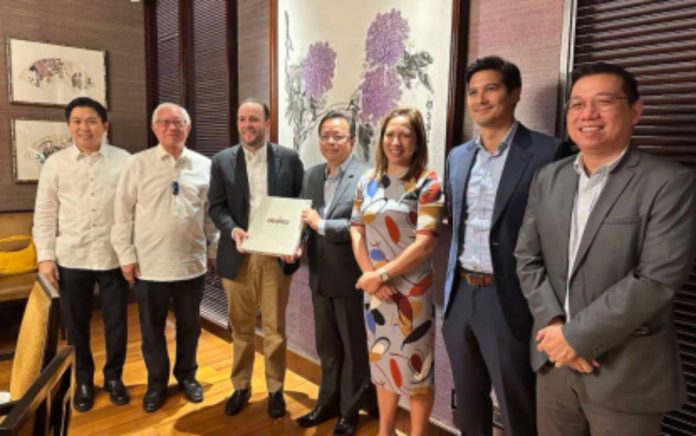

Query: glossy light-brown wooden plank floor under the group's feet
left=0, top=304, right=388, bottom=436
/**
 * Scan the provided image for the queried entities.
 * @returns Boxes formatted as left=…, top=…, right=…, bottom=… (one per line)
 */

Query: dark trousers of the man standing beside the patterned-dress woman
left=312, top=291, right=375, bottom=416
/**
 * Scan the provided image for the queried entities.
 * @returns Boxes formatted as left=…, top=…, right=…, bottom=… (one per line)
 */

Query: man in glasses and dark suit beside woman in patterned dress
left=297, top=112, right=374, bottom=435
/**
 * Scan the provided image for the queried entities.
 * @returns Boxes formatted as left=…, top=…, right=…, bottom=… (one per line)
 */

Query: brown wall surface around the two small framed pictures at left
left=0, top=0, right=147, bottom=212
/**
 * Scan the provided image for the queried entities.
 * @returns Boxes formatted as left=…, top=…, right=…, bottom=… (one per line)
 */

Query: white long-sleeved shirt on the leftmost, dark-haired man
left=33, top=144, right=130, bottom=271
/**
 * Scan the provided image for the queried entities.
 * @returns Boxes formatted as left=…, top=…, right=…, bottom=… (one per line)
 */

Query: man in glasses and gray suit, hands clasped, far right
left=515, top=64, right=696, bottom=436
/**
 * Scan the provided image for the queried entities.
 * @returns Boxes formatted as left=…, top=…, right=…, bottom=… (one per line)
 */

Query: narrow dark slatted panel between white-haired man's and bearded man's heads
left=189, top=0, right=231, bottom=156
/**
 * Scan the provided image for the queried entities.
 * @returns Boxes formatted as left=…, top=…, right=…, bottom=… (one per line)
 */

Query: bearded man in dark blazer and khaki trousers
left=209, top=99, right=304, bottom=418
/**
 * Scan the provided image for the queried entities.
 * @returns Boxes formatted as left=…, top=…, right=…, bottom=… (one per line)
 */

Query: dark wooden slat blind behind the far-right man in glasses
left=573, top=0, right=696, bottom=436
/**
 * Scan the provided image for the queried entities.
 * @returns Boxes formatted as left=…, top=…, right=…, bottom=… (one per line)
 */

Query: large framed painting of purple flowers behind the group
left=271, top=0, right=468, bottom=176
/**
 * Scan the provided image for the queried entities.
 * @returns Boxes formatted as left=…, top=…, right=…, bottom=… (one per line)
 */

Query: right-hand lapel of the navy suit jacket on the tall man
left=491, top=124, right=532, bottom=227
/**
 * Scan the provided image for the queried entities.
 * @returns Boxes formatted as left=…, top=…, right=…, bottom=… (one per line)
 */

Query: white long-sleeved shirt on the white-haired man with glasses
left=111, top=145, right=218, bottom=282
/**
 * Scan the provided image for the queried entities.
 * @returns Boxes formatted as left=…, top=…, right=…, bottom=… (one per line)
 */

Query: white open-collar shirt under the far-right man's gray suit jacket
left=563, top=147, right=628, bottom=321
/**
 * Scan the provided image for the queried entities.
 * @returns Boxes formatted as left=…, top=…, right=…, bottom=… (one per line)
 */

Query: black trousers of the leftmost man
left=58, top=266, right=128, bottom=383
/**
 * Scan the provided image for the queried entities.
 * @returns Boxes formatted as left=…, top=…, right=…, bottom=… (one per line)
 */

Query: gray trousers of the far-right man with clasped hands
left=537, top=365, right=662, bottom=436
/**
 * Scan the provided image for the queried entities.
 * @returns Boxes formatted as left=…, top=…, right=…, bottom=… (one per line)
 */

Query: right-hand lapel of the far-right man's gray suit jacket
left=566, top=150, right=638, bottom=278
